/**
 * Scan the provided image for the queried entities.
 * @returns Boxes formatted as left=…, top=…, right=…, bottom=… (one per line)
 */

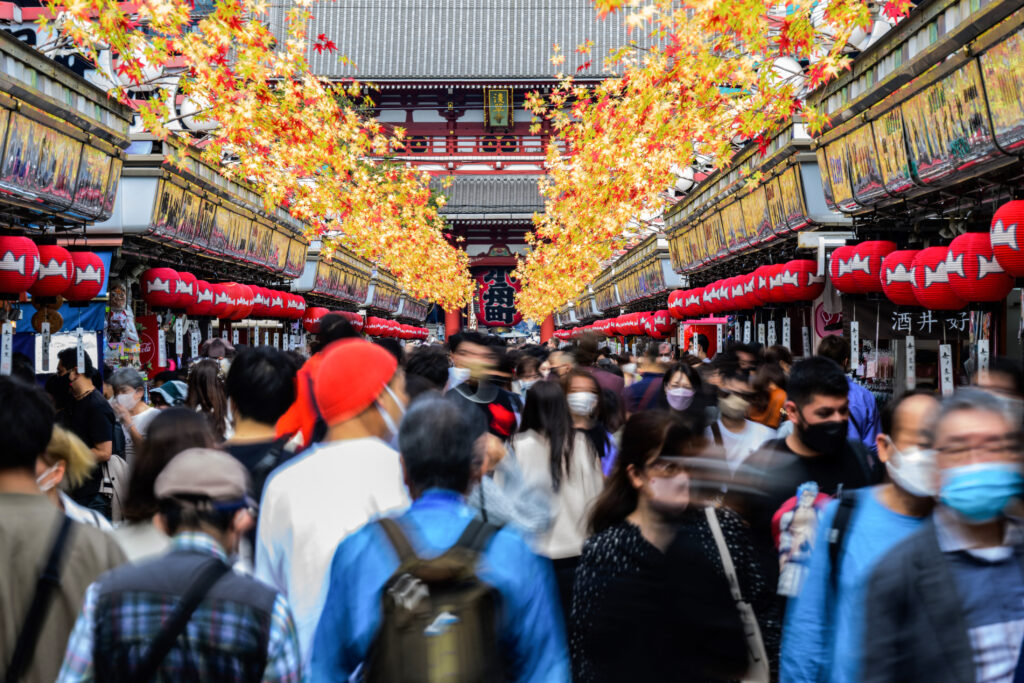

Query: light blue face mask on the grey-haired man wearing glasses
left=939, top=463, right=1024, bottom=524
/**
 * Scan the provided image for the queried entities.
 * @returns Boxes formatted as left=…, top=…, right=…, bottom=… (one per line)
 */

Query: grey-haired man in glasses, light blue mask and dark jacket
left=861, top=389, right=1024, bottom=683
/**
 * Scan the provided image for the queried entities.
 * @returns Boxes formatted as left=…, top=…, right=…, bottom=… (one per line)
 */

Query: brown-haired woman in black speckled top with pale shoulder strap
left=568, top=412, right=780, bottom=683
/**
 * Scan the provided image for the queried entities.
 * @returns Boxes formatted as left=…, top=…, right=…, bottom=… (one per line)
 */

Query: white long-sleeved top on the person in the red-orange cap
left=256, top=438, right=410, bottom=665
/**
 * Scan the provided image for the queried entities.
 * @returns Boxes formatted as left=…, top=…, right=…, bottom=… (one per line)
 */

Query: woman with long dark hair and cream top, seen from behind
left=512, top=373, right=604, bottom=610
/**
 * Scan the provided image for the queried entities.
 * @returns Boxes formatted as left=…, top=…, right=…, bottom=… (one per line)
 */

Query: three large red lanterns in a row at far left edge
left=0, top=236, right=106, bottom=302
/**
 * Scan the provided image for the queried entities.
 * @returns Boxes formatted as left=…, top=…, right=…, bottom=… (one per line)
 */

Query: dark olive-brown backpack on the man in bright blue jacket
left=366, top=518, right=507, bottom=683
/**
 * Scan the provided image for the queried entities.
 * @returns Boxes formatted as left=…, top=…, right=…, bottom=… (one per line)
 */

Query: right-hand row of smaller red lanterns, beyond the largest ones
left=669, top=259, right=825, bottom=319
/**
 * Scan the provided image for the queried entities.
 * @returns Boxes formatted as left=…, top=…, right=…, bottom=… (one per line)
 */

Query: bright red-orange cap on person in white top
left=313, top=339, right=398, bottom=426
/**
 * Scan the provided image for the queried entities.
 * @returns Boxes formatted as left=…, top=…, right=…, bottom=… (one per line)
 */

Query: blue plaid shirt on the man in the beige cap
left=57, top=532, right=302, bottom=683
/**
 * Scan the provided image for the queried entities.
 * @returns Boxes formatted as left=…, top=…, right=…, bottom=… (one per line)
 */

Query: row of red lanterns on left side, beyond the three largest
left=139, top=267, right=306, bottom=321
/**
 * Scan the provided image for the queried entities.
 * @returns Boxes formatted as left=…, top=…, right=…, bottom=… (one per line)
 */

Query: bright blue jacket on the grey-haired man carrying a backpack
left=311, top=489, right=569, bottom=682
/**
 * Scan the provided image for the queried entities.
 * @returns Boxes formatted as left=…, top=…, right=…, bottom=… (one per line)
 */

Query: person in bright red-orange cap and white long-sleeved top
left=256, top=339, right=410, bottom=661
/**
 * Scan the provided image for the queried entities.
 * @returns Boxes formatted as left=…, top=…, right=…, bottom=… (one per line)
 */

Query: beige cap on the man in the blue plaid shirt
left=153, top=449, right=249, bottom=501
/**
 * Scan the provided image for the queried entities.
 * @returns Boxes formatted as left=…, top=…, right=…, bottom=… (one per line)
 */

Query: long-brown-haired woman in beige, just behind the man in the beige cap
left=114, top=408, right=217, bottom=562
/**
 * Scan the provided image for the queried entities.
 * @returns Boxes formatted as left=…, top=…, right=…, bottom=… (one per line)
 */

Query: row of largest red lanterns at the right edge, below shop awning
left=828, top=219, right=1024, bottom=310
